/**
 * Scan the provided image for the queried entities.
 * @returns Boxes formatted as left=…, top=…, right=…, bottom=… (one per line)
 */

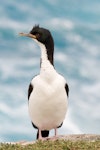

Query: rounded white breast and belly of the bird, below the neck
left=29, top=76, right=68, bottom=130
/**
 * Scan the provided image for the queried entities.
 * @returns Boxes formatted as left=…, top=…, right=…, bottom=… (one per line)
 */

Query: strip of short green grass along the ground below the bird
left=0, top=140, right=100, bottom=150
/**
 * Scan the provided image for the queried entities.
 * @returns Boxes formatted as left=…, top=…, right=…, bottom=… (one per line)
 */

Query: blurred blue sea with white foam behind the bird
left=0, top=0, right=100, bottom=142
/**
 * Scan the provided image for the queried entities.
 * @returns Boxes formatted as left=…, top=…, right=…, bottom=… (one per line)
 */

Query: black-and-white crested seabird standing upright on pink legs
left=19, top=25, right=69, bottom=140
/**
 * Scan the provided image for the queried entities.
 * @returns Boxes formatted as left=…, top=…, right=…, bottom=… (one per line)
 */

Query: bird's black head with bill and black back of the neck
left=19, top=25, right=54, bottom=64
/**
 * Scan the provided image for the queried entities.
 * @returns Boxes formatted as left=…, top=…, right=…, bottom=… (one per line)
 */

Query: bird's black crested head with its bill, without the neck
left=19, top=25, right=53, bottom=46
